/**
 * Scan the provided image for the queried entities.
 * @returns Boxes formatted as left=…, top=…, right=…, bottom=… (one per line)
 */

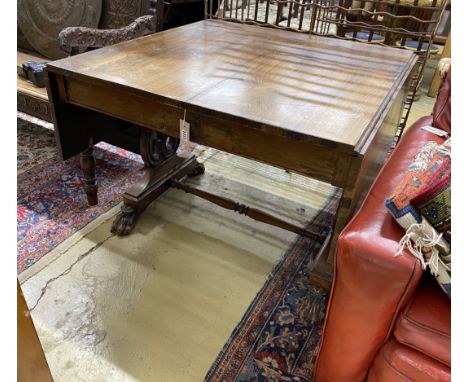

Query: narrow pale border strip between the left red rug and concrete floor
left=17, top=202, right=122, bottom=284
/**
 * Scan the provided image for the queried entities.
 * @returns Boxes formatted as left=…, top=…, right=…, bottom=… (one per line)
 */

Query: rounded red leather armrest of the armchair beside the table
left=315, top=117, right=443, bottom=382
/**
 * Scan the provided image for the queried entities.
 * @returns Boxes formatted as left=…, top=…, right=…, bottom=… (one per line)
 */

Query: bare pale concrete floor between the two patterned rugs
left=22, top=149, right=332, bottom=382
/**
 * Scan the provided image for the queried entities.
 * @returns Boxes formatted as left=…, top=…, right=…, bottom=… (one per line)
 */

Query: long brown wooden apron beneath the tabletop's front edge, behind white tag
left=62, top=75, right=353, bottom=187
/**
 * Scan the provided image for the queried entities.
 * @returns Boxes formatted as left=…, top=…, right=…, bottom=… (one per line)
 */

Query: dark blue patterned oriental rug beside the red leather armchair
left=205, top=191, right=341, bottom=382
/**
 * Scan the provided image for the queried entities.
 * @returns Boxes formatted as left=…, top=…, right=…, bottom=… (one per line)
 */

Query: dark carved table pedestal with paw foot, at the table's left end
left=111, top=128, right=205, bottom=236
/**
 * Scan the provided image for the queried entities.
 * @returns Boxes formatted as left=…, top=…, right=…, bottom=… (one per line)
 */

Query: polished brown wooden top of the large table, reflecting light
left=48, top=20, right=416, bottom=150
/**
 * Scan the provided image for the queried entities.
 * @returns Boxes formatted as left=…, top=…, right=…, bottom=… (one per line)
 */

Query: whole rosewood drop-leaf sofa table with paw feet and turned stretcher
left=47, top=20, right=416, bottom=264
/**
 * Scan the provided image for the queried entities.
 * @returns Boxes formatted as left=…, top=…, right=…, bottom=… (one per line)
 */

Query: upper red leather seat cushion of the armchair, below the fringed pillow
left=394, top=275, right=451, bottom=366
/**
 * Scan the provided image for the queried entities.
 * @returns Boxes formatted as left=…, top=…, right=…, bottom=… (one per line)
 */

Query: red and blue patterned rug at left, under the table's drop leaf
left=17, top=118, right=142, bottom=275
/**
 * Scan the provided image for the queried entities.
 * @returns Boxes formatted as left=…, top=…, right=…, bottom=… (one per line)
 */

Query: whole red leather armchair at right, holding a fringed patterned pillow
left=315, top=71, right=451, bottom=382
